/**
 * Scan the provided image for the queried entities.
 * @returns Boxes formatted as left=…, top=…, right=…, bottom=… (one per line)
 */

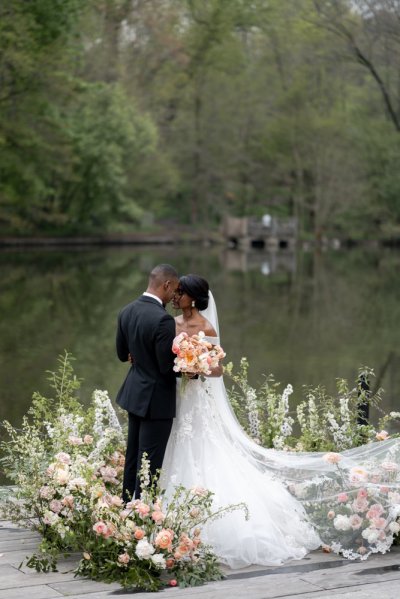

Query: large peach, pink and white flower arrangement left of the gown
left=1, top=354, right=245, bottom=591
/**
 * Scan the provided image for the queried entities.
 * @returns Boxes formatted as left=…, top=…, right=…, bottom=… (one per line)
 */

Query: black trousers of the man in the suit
left=122, top=413, right=172, bottom=501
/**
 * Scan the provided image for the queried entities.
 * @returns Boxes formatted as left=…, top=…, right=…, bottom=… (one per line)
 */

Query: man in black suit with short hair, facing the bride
left=117, top=264, right=179, bottom=501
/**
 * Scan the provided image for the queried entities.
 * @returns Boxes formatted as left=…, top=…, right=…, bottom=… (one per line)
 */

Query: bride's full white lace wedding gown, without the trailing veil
left=161, top=294, right=320, bottom=568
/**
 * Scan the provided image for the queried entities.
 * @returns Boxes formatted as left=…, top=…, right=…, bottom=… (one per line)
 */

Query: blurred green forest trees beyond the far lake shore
left=0, top=0, right=400, bottom=240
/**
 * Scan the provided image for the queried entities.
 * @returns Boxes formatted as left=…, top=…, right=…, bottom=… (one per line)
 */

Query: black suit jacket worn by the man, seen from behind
left=117, top=295, right=176, bottom=419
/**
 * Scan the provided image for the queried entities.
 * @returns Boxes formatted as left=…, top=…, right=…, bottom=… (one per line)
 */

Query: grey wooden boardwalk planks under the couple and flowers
left=0, top=521, right=400, bottom=599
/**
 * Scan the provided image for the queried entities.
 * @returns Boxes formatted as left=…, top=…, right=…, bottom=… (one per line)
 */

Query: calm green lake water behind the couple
left=0, top=246, right=400, bottom=432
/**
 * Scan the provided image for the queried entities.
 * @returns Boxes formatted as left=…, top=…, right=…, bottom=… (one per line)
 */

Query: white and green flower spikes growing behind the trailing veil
left=224, top=358, right=400, bottom=452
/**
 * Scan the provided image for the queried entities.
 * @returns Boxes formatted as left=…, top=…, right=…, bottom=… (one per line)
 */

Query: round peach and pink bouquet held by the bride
left=172, top=331, right=226, bottom=375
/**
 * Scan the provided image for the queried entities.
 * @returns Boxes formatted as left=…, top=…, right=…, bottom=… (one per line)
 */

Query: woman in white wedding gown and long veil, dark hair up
left=161, top=275, right=400, bottom=568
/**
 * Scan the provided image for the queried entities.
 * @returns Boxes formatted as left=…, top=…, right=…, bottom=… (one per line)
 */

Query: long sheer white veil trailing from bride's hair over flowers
left=202, top=292, right=400, bottom=559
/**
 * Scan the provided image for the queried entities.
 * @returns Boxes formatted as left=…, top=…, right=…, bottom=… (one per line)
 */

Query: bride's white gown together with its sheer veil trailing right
left=161, top=293, right=400, bottom=568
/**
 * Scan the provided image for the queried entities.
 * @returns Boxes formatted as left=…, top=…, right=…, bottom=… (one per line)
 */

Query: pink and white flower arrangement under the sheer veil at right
left=288, top=450, right=400, bottom=559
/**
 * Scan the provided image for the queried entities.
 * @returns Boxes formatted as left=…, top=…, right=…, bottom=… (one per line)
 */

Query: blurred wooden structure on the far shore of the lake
left=222, top=215, right=297, bottom=249
